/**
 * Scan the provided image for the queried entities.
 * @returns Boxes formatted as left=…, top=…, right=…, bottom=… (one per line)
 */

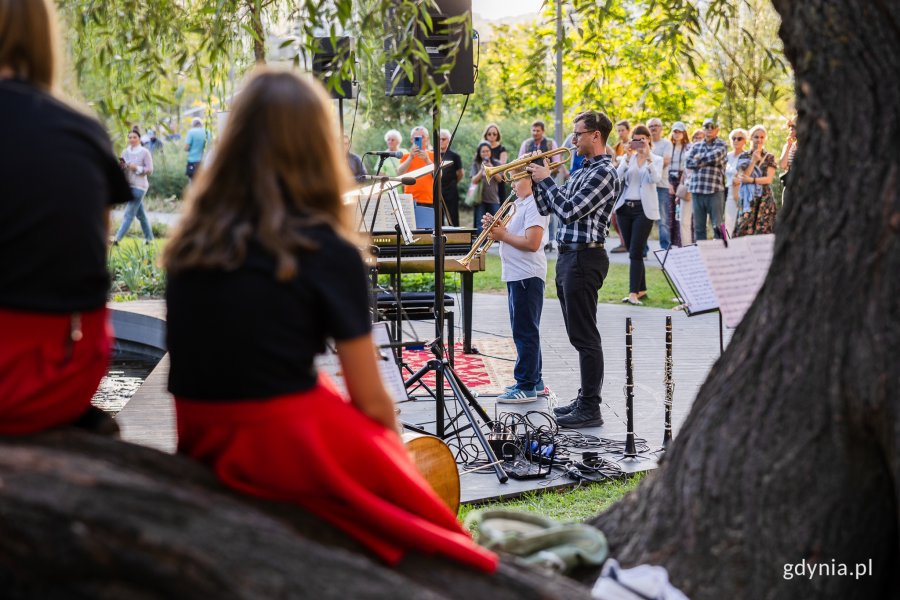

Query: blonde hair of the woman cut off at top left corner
left=0, top=0, right=59, bottom=90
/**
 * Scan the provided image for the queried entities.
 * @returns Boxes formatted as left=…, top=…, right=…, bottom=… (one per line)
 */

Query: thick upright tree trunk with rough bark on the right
left=593, top=0, right=900, bottom=599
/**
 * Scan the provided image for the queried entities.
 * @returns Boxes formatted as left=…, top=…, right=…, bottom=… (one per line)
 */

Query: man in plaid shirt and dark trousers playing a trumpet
left=526, top=110, right=622, bottom=428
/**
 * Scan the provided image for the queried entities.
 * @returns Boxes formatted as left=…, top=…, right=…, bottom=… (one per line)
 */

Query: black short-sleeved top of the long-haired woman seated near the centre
left=166, top=225, right=371, bottom=400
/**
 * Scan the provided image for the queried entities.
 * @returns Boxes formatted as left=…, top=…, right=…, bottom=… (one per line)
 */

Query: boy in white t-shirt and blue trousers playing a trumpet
left=482, top=170, right=550, bottom=404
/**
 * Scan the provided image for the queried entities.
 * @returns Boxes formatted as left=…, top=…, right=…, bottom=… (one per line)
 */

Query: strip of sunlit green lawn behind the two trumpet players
left=474, top=254, right=675, bottom=308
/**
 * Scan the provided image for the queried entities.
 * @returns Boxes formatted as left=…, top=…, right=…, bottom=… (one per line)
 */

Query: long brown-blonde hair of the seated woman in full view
left=165, top=68, right=352, bottom=281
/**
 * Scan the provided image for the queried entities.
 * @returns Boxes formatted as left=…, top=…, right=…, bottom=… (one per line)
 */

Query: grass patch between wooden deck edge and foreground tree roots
left=459, top=473, right=645, bottom=521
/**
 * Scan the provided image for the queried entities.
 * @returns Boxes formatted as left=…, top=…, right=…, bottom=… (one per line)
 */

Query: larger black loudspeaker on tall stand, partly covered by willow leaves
left=384, top=0, right=475, bottom=96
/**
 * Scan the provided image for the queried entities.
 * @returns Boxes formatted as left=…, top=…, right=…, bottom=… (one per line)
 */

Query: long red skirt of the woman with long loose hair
left=175, top=374, right=497, bottom=572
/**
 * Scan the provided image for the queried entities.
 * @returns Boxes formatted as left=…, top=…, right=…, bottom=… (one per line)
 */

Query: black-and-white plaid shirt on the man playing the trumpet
left=534, top=154, right=622, bottom=244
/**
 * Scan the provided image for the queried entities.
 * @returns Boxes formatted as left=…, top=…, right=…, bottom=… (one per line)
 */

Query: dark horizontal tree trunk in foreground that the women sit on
left=0, top=431, right=590, bottom=600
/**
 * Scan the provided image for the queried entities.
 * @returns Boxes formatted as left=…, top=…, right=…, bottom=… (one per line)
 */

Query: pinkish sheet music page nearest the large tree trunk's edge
left=697, top=234, right=775, bottom=328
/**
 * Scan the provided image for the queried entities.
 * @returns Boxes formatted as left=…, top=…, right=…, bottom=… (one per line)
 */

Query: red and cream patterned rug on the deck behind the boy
left=403, top=338, right=516, bottom=396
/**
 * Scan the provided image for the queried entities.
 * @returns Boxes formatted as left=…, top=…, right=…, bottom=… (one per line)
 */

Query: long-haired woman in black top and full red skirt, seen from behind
left=165, top=69, right=497, bottom=571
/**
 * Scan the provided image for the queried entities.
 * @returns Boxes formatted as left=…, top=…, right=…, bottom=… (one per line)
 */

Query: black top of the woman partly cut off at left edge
left=0, top=80, right=131, bottom=313
